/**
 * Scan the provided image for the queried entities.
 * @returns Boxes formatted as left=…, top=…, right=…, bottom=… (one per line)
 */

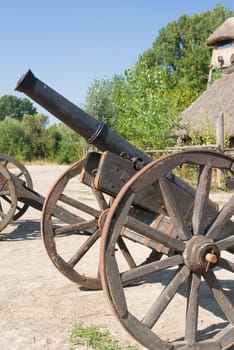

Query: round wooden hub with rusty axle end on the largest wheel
left=183, top=235, right=220, bottom=272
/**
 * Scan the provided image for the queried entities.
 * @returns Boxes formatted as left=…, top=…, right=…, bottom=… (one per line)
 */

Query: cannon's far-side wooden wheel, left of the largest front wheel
left=41, top=159, right=102, bottom=289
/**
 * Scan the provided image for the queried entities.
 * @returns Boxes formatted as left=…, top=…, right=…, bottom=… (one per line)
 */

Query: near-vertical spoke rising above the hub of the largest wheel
left=192, top=166, right=212, bottom=235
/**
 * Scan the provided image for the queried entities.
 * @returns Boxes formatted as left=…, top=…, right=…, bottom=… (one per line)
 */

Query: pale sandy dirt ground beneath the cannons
left=0, top=165, right=233, bottom=350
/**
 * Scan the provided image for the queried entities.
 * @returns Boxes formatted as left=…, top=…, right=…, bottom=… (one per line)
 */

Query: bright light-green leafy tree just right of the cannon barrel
left=114, top=61, right=178, bottom=149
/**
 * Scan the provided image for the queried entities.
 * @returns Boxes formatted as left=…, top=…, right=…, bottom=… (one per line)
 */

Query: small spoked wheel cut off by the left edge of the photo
left=0, top=163, right=17, bottom=231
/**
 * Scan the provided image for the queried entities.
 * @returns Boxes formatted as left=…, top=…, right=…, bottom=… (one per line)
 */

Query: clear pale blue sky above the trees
left=0, top=0, right=234, bottom=124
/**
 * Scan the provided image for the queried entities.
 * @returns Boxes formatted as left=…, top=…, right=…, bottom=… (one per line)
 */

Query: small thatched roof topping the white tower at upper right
left=206, top=17, right=234, bottom=46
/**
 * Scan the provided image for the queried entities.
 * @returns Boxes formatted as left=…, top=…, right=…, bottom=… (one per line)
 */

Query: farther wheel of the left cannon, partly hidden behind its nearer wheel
left=0, top=153, right=33, bottom=220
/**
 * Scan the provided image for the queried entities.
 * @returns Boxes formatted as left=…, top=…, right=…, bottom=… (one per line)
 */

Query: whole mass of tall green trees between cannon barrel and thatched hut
left=106, top=5, right=233, bottom=149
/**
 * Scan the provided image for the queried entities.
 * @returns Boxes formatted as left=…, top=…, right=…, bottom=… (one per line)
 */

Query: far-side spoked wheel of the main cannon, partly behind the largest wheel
left=41, top=159, right=161, bottom=289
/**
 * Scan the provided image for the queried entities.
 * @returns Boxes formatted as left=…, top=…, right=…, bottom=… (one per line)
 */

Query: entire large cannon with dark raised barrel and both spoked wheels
left=16, top=71, right=234, bottom=350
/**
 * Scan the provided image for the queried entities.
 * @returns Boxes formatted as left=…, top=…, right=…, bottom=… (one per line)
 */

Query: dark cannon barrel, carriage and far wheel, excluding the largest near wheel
left=16, top=70, right=212, bottom=289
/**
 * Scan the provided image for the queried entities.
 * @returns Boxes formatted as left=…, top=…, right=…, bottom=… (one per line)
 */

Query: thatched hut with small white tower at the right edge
left=180, top=17, right=234, bottom=139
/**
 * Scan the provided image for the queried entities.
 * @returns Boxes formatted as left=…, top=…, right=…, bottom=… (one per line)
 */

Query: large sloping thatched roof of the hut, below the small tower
left=181, top=65, right=234, bottom=137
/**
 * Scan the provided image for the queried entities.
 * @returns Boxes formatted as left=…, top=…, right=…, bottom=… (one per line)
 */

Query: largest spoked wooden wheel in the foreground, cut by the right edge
left=100, top=151, right=234, bottom=350
